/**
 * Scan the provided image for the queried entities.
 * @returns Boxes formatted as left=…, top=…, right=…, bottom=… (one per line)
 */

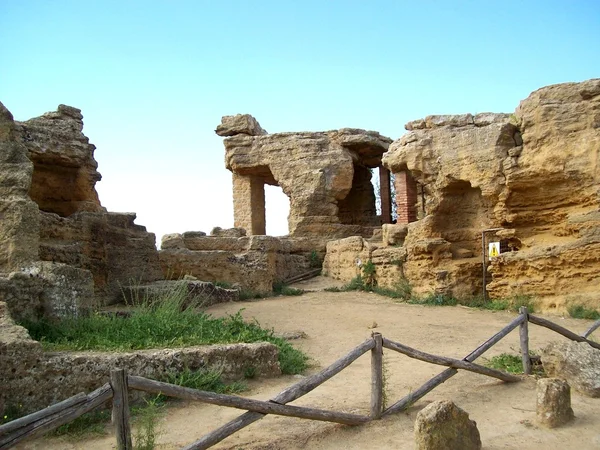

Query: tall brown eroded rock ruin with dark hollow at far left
left=0, top=104, right=162, bottom=312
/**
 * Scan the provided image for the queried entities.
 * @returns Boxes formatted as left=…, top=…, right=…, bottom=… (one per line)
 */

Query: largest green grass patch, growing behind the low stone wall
left=20, top=286, right=308, bottom=374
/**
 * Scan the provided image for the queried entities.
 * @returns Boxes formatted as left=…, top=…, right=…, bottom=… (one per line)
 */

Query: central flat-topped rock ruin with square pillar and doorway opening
left=217, top=117, right=391, bottom=237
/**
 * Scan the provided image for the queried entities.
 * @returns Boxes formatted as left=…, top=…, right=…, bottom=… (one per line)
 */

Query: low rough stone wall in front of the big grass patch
left=0, top=302, right=281, bottom=414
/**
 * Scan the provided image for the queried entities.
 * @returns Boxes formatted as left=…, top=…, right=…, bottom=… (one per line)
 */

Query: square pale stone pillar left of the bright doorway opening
left=233, top=173, right=266, bottom=235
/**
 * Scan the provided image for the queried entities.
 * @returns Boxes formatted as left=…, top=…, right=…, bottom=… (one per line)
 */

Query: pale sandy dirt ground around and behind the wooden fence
left=20, top=278, right=600, bottom=450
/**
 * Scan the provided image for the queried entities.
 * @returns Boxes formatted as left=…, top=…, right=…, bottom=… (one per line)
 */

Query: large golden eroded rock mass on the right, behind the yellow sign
left=368, top=80, right=600, bottom=308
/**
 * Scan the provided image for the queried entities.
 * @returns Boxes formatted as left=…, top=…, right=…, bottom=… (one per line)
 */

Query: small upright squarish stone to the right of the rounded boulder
left=536, top=378, right=575, bottom=428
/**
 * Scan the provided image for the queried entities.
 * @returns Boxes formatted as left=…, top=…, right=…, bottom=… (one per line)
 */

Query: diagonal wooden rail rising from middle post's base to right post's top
left=383, top=314, right=526, bottom=416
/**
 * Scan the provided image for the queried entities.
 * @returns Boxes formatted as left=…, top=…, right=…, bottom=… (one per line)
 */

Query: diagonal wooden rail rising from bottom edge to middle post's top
left=184, top=339, right=375, bottom=450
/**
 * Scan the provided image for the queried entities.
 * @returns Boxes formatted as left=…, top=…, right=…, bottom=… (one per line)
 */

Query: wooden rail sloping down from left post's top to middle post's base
left=128, top=376, right=369, bottom=425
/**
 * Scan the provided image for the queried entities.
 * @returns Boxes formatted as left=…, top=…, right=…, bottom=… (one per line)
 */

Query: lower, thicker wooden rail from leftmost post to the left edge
left=0, top=383, right=113, bottom=450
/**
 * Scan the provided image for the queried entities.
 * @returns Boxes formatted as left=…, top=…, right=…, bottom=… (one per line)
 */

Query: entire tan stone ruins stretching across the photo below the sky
left=0, top=79, right=600, bottom=410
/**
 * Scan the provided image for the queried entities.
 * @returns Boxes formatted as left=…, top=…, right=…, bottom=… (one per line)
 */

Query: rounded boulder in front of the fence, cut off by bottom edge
left=415, top=400, right=481, bottom=450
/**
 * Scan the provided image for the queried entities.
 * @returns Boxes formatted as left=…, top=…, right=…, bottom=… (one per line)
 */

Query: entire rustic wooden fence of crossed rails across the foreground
left=0, top=307, right=600, bottom=450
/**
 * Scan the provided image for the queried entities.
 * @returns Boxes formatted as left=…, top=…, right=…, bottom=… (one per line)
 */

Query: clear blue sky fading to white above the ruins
left=0, top=0, right=600, bottom=240
